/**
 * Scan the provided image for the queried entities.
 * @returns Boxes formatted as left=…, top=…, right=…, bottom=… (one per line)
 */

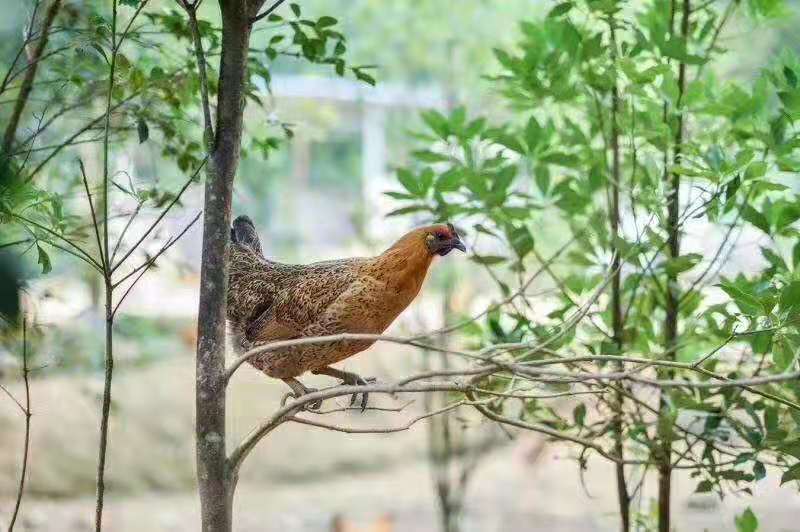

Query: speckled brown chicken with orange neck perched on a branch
left=227, top=216, right=466, bottom=410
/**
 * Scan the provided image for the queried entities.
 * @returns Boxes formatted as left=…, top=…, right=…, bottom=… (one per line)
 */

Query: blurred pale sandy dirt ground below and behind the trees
left=0, top=351, right=800, bottom=532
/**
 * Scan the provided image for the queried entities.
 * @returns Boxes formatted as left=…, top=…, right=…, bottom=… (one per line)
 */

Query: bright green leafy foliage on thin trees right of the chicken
left=387, top=0, right=800, bottom=516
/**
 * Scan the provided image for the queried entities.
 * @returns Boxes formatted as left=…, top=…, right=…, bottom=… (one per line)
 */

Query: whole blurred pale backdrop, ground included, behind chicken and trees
left=0, top=0, right=800, bottom=532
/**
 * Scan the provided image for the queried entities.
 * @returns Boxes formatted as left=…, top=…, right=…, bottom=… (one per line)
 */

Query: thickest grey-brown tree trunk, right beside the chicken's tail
left=196, top=0, right=250, bottom=532
